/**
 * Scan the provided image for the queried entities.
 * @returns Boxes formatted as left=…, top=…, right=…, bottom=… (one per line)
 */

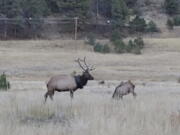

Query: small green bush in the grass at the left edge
left=0, top=73, right=10, bottom=90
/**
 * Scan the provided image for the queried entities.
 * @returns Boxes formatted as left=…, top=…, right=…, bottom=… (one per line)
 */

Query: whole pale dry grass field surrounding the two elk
left=0, top=38, right=180, bottom=135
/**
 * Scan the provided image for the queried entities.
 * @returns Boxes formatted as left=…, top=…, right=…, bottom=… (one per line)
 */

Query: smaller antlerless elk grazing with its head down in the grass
left=112, top=80, right=136, bottom=99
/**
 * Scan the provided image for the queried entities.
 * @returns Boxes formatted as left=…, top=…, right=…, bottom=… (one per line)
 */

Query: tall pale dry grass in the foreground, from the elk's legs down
left=0, top=88, right=180, bottom=135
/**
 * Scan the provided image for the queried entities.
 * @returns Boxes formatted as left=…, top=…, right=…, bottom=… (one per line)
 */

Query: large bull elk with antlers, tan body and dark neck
left=44, top=57, right=95, bottom=102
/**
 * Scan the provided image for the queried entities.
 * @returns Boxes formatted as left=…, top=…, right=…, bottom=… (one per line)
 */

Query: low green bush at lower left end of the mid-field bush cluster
left=94, top=43, right=110, bottom=53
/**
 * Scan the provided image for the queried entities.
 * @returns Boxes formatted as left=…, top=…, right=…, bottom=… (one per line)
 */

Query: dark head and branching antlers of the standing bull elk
left=76, top=57, right=95, bottom=80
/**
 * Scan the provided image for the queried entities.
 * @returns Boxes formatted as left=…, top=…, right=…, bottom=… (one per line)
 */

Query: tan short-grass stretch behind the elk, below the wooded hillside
left=0, top=39, right=180, bottom=81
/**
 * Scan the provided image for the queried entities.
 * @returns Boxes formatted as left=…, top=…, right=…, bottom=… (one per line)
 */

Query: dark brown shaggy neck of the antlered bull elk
left=75, top=75, right=88, bottom=89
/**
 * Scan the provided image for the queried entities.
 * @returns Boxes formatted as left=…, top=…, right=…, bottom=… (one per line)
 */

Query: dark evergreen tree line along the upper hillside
left=0, top=0, right=180, bottom=38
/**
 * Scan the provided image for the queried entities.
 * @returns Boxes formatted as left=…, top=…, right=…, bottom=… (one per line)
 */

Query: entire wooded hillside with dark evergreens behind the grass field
left=0, top=0, right=180, bottom=39
